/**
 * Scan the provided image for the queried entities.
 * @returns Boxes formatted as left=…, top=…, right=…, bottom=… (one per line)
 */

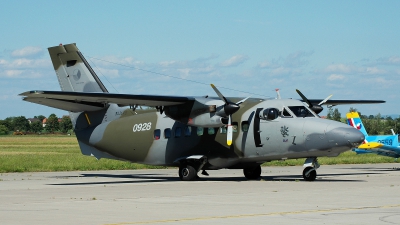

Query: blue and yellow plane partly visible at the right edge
left=346, top=112, right=400, bottom=159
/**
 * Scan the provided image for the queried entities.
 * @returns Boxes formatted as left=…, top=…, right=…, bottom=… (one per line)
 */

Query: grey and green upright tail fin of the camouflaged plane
left=48, top=44, right=108, bottom=92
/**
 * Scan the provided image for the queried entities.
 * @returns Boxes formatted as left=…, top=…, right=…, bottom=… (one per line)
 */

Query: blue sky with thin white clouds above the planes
left=0, top=0, right=400, bottom=119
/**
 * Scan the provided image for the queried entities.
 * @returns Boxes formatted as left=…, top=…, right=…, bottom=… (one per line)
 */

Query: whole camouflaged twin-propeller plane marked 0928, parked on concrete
left=20, top=44, right=384, bottom=181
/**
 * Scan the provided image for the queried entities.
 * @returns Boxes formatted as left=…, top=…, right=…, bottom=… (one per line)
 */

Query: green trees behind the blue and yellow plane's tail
left=327, top=107, right=400, bottom=135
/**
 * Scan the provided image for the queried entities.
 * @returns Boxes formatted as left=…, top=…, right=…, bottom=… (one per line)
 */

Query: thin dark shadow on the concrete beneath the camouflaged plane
left=49, top=171, right=384, bottom=186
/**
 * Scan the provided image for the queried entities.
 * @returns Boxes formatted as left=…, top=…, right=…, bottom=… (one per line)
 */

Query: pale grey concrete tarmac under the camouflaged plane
left=0, top=163, right=400, bottom=225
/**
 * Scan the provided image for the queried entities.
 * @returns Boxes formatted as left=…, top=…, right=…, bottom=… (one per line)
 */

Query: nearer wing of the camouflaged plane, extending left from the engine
left=19, top=91, right=194, bottom=112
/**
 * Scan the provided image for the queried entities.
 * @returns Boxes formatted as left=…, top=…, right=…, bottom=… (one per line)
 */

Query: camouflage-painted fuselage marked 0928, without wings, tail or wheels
left=76, top=99, right=361, bottom=169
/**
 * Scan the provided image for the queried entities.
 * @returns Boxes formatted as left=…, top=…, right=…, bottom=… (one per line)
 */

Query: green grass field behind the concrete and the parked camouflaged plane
left=0, top=135, right=394, bottom=173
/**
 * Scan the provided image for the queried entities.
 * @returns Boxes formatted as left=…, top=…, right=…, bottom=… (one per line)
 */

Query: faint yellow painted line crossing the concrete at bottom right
left=105, top=205, right=400, bottom=225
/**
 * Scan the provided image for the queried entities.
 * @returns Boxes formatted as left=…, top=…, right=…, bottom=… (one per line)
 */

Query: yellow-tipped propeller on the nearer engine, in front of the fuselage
left=211, top=84, right=249, bottom=146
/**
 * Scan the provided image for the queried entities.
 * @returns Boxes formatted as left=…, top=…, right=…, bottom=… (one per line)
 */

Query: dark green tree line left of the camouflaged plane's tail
left=0, top=113, right=72, bottom=135
